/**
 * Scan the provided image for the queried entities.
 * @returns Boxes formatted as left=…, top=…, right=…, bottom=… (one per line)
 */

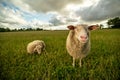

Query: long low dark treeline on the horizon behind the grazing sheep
left=0, top=28, right=43, bottom=32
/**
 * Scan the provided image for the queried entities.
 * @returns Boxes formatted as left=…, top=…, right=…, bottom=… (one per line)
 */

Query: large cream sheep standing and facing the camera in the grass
left=66, top=24, right=98, bottom=67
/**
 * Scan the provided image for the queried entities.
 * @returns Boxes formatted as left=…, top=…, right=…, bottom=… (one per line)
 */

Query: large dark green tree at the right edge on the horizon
left=107, top=17, right=120, bottom=28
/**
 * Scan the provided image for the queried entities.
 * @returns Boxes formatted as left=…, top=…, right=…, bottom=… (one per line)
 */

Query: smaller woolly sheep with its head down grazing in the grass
left=27, top=40, right=45, bottom=54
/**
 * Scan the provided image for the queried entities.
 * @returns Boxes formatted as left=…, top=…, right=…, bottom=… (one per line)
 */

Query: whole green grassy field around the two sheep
left=0, top=29, right=120, bottom=80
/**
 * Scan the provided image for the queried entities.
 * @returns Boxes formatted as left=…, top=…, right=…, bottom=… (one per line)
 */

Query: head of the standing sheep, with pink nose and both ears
left=68, top=25, right=98, bottom=43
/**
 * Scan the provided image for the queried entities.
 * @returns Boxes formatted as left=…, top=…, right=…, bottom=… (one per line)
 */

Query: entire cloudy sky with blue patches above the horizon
left=0, top=0, right=120, bottom=29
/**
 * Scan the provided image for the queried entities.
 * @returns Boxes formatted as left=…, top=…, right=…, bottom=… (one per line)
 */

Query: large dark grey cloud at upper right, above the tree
left=76, top=0, right=120, bottom=21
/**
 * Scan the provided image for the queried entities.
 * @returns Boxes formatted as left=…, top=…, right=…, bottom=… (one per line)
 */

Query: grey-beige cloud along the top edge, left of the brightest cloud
left=23, top=0, right=83, bottom=12
